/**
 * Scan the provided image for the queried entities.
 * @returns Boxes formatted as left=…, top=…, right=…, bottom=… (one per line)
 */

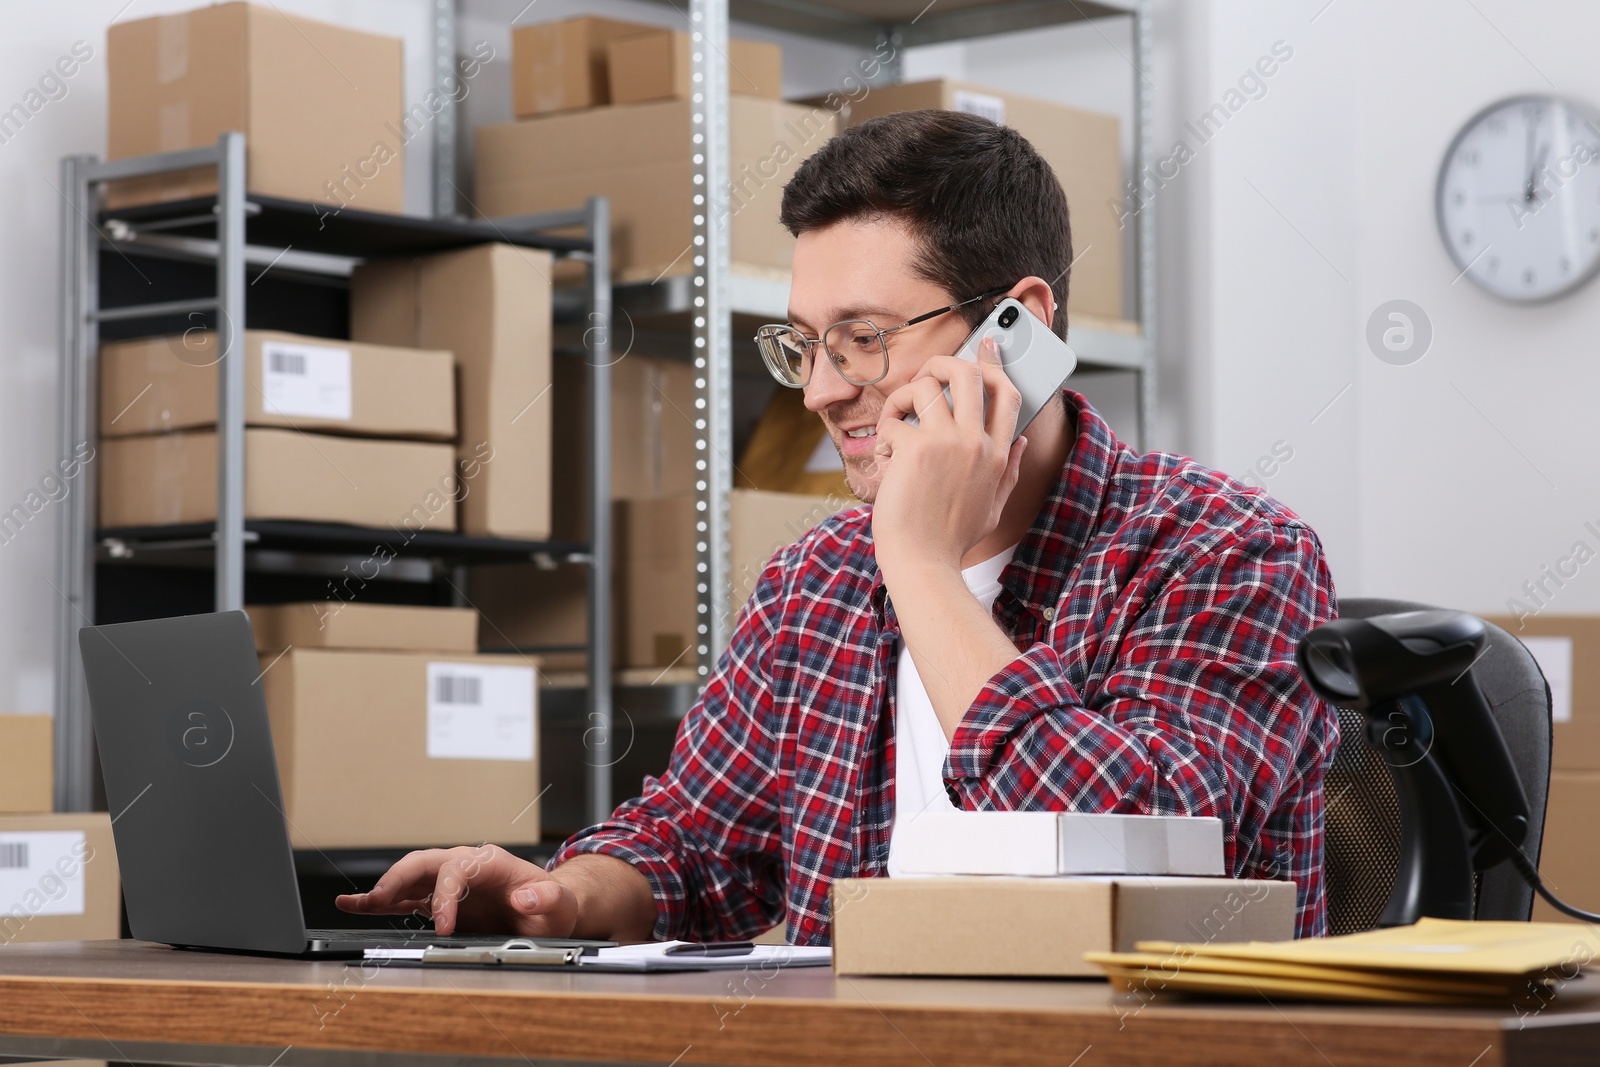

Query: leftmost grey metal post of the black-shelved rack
left=53, top=155, right=99, bottom=811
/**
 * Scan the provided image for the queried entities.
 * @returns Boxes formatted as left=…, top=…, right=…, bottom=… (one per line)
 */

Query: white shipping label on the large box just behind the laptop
left=427, top=664, right=534, bottom=760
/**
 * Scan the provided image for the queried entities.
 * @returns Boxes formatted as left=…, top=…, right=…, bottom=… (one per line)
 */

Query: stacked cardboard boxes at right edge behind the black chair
left=1486, top=614, right=1600, bottom=921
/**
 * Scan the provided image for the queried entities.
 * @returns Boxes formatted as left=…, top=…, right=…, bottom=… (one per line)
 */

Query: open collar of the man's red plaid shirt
left=866, top=389, right=1126, bottom=625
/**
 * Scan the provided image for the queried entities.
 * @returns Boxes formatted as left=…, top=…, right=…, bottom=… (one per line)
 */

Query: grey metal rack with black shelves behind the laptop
left=54, top=133, right=611, bottom=819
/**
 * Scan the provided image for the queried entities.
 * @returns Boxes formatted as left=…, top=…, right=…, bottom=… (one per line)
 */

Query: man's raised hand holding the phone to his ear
left=872, top=341, right=1027, bottom=581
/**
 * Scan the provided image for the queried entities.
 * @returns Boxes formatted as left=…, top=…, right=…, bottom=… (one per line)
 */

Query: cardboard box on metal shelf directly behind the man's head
left=846, top=78, right=1123, bottom=318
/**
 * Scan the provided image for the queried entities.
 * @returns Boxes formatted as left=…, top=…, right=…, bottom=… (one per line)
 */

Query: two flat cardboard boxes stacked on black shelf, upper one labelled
left=99, top=330, right=459, bottom=530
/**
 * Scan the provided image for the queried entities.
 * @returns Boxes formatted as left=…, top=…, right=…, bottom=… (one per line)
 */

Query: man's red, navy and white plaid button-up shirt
left=550, top=392, right=1338, bottom=944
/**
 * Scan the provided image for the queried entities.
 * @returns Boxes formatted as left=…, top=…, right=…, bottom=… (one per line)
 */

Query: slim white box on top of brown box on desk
left=894, top=811, right=1224, bottom=877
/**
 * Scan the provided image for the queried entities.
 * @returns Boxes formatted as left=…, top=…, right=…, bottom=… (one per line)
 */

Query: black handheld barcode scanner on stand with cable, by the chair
left=1294, top=611, right=1600, bottom=926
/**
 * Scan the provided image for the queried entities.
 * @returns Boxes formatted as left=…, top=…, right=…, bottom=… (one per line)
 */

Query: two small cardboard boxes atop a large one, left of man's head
left=474, top=18, right=812, bottom=282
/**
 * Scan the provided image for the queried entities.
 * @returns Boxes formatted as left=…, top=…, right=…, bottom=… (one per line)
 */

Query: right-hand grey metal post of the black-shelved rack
left=584, top=197, right=619, bottom=825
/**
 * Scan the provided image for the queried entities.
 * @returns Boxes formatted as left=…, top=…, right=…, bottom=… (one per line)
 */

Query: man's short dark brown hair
left=779, top=110, right=1072, bottom=338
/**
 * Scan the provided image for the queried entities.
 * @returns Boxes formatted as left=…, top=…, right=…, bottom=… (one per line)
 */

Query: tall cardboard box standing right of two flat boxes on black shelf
left=350, top=244, right=550, bottom=541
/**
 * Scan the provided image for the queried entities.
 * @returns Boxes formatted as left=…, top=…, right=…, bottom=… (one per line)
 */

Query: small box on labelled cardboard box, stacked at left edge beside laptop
left=0, top=713, right=122, bottom=945
